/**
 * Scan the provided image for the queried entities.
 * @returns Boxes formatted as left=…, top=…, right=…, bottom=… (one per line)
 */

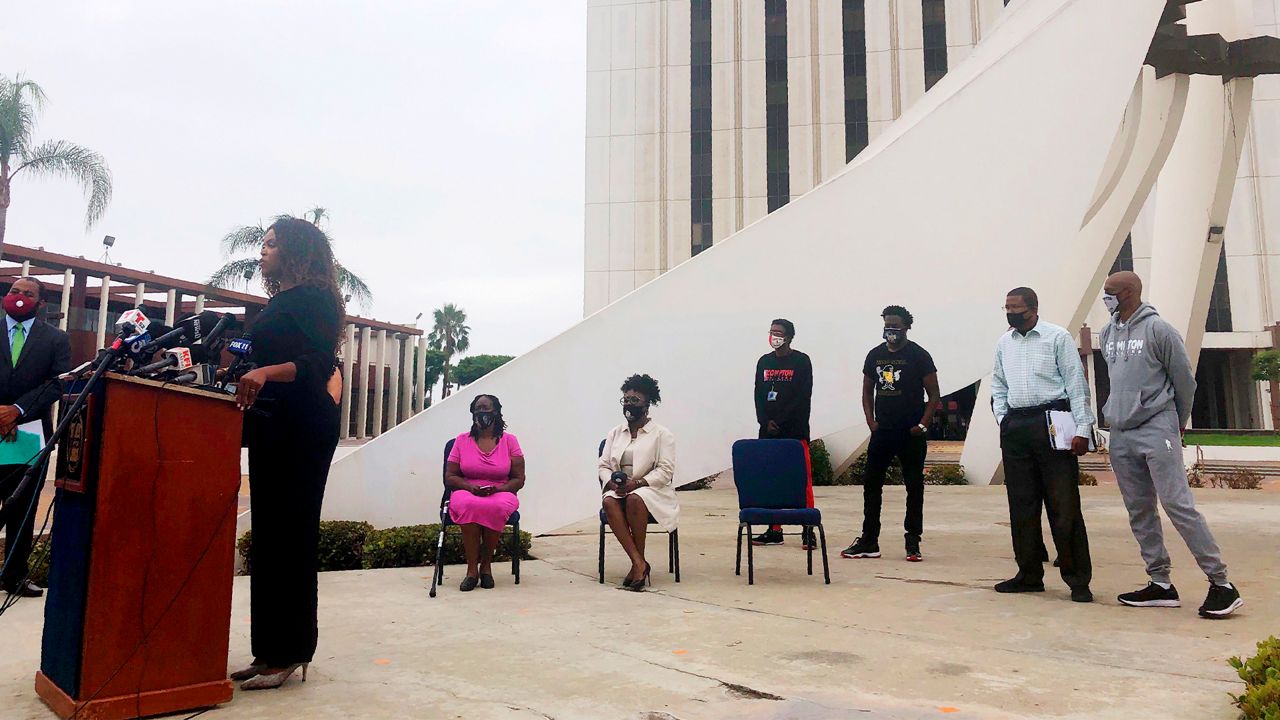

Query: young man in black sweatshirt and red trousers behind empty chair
left=751, top=318, right=817, bottom=550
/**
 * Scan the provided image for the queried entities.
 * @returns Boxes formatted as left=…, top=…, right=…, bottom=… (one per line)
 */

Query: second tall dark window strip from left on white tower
left=764, top=0, right=791, bottom=213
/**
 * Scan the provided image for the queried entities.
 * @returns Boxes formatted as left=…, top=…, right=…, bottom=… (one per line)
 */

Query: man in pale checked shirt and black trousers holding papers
left=991, top=287, right=1096, bottom=602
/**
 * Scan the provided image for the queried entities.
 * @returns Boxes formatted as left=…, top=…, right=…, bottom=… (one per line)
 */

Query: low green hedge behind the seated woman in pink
left=236, top=520, right=532, bottom=575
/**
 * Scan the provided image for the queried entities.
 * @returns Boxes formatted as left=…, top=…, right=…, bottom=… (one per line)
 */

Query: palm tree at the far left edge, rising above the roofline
left=0, top=76, right=111, bottom=250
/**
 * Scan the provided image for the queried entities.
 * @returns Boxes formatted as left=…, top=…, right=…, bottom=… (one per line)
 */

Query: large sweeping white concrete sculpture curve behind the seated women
left=325, top=0, right=1165, bottom=532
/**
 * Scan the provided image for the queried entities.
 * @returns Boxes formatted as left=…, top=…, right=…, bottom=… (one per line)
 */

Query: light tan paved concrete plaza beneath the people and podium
left=0, top=483, right=1280, bottom=720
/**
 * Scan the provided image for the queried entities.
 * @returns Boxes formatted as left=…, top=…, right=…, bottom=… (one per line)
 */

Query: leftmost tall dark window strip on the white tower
left=689, top=0, right=712, bottom=255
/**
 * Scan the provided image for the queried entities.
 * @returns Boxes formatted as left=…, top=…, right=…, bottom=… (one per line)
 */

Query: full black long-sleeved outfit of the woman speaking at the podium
left=244, top=287, right=342, bottom=667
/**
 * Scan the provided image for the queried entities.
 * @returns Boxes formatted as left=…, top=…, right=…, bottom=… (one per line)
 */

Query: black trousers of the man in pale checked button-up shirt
left=1000, top=413, right=1093, bottom=588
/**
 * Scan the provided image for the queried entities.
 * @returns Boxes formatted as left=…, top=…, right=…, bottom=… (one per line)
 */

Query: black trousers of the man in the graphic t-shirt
left=863, top=430, right=929, bottom=542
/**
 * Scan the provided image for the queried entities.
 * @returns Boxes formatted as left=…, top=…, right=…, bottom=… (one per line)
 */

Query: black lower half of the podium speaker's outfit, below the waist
left=246, top=396, right=338, bottom=667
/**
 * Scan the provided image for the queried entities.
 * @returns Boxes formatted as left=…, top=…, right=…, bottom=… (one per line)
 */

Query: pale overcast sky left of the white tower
left=0, top=0, right=586, bottom=355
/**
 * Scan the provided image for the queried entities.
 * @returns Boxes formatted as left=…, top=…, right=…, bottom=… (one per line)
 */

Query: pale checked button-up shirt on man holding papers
left=991, top=320, right=1097, bottom=437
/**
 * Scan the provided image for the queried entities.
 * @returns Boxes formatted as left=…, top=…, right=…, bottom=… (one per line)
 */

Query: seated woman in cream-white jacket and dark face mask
left=599, top=375, right=680, bottom=592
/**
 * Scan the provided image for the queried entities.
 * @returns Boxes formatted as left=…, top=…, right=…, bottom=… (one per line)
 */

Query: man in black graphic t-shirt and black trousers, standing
left=840, top=305, right=940, bottom=562
